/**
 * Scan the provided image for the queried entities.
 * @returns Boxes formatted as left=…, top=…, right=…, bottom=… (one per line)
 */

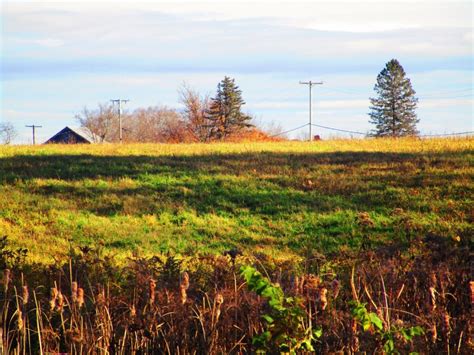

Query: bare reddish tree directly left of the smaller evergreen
left=178, top=84, right=210, bottom=142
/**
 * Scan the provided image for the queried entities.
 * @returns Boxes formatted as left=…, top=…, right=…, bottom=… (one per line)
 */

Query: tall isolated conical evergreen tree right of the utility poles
left=369, top=59, right=419, bottom=137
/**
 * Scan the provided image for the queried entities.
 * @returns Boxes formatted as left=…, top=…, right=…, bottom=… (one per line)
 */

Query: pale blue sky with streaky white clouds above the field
left=0, top=0, right=474, bottom=144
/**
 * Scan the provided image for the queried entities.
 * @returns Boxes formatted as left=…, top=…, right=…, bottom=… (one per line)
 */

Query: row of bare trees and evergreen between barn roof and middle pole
left=76, top=76, right=271, bottom=143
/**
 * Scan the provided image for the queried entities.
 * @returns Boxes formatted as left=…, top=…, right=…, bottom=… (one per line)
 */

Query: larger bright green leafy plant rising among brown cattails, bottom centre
left=240, top=266, right=322, bottom=354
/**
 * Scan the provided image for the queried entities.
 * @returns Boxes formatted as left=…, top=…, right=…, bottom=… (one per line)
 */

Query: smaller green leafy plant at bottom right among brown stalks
left=350, top=301, right=424, bottom=354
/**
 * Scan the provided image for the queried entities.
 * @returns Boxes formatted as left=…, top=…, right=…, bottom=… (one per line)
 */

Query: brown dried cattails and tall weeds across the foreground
left=0, top=237, right=472, bottom=354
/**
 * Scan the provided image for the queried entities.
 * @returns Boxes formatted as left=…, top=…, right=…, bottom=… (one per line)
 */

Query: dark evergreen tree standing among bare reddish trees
left=206, top=76, right=253, bottom=140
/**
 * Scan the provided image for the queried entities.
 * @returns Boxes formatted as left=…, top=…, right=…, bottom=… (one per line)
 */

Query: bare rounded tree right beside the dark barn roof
left=75, top=104, right=118, bottom=142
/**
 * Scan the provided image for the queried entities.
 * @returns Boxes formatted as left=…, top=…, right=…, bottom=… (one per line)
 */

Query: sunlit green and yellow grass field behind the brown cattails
left=0, top=139, right=474, bottom=263
